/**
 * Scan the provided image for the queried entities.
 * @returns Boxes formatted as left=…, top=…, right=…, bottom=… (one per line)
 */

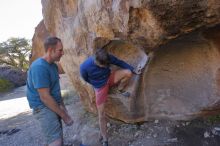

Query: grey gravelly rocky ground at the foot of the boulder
left=0, top=76, right=220, bottom=146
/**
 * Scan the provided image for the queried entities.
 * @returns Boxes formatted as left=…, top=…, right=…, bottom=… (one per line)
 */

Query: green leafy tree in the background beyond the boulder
left=0, top=38, right=31, bottom=71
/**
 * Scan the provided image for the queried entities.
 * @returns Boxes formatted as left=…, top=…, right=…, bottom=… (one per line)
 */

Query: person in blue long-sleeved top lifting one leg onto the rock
left=80, top=48, right=141, bottom=146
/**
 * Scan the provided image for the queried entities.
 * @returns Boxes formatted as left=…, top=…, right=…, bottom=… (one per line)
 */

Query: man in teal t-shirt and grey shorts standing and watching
left=27, top=37, right=73, bottom=146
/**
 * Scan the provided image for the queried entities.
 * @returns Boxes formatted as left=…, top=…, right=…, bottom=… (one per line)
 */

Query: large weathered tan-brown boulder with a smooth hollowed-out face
left=30, top=0, right=220, bottom=123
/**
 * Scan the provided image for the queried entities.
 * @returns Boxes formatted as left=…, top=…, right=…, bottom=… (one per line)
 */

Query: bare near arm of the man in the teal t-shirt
left=37, top=88, right=73, bottom=126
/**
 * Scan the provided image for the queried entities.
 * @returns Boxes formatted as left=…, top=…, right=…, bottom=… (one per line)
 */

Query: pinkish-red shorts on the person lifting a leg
left=95, top=72, right=115, bottom=106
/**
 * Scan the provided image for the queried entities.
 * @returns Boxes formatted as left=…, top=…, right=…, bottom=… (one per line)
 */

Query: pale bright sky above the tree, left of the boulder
left=0, top=0, right=43, bottom=42
